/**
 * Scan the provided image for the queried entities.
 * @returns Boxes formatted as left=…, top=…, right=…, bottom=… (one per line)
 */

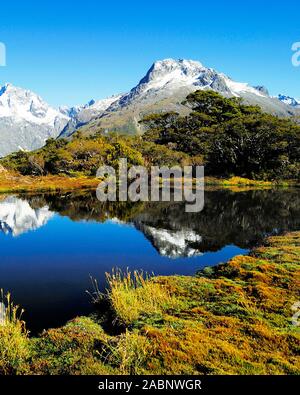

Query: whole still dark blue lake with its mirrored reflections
left=0, top=189, right=300, bottom=333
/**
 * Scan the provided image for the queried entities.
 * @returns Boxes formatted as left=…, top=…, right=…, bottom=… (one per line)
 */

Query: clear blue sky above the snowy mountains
left=0, top=0, right=300, bottom=106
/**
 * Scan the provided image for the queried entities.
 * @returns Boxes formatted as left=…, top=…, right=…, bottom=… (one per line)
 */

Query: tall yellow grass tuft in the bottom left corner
left=0, top=290, right=29, bottom=375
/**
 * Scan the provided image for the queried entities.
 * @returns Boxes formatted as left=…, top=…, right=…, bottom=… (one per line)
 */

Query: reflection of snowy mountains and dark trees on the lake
left=0, top=189, right=300, bottom=258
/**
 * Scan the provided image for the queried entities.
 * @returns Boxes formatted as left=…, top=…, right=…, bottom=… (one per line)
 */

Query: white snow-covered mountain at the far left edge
left=0, top=84, right=70, bottom=157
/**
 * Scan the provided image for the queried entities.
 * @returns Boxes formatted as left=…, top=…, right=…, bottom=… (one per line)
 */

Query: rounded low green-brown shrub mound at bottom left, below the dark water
left=31, top=317, right=115, bottom=375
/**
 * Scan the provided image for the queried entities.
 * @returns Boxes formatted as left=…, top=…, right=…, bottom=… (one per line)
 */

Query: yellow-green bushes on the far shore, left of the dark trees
left=1, top=133, right=144, bottom=177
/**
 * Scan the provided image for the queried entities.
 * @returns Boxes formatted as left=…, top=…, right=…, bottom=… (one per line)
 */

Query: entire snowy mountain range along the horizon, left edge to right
left=0, top=59, right=300, bottom=157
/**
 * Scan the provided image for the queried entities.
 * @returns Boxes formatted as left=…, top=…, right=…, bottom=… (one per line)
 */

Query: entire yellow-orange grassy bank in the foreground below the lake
left=0, top=232, right=300, bottom=374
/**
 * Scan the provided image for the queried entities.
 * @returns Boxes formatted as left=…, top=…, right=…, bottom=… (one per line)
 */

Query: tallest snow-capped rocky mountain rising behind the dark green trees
left=65, top=59, right=295, bottom=136
